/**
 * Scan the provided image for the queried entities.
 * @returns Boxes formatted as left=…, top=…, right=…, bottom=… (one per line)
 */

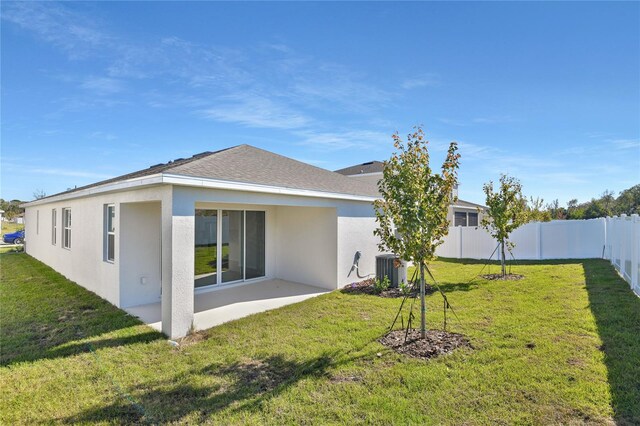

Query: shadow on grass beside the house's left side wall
left=0, top=254, right=164, bottom=366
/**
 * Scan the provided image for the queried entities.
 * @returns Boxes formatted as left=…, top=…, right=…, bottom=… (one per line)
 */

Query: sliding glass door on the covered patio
left=194, top=209, right=265, bottom=287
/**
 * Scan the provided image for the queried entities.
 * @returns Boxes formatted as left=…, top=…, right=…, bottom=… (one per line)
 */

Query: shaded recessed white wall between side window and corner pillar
left=116, top=202, right=162, bottom=307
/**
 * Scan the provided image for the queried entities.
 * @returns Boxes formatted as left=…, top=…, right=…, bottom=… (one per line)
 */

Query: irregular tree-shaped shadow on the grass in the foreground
left=63, top=353, right=337, bottom=424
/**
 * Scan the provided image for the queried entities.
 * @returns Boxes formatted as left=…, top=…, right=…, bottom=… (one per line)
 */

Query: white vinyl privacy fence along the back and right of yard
left=436, top=215, right=640, bottom=295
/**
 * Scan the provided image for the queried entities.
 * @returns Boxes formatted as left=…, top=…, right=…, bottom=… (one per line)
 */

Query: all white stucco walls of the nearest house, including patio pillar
left=26, top=184, right=377, bottom=338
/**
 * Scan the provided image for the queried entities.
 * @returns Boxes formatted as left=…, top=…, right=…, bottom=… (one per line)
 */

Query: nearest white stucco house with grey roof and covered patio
left=24, top=145, right=378, bottom=338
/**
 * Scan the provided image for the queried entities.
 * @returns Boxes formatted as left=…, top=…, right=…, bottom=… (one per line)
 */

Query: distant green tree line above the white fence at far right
left=546, top=184, right=640, bottom=220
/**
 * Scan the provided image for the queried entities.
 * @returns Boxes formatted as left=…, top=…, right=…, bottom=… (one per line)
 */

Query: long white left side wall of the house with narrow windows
left=25, top=187, right=170, bottom=306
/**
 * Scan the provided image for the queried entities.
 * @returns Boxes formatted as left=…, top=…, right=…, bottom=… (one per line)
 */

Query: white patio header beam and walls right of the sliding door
left=174, top=187, right=378, bottom=289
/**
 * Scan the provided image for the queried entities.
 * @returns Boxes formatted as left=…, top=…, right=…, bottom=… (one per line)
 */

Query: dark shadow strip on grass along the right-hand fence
left=582, top=260, right=640, bottom=425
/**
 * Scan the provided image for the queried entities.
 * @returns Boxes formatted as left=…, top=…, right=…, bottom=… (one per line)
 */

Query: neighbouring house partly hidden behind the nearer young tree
left=336, top=161, right=486, bottom=226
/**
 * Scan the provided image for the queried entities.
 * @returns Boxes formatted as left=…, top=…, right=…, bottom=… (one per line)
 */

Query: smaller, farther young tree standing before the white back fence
left=481, top=175, right=529, bottom=278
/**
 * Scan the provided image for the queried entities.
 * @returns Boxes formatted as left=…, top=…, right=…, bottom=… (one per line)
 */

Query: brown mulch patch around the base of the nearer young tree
left=378, top=329, right=472, bottom=359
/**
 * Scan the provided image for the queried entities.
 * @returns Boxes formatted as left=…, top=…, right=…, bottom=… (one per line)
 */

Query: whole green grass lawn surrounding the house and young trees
left=0, top=254, right=640, bottom=425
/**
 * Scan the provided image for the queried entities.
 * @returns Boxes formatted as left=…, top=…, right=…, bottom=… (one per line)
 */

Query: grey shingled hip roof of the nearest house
left=33, top=145, right=379, bottom=202
